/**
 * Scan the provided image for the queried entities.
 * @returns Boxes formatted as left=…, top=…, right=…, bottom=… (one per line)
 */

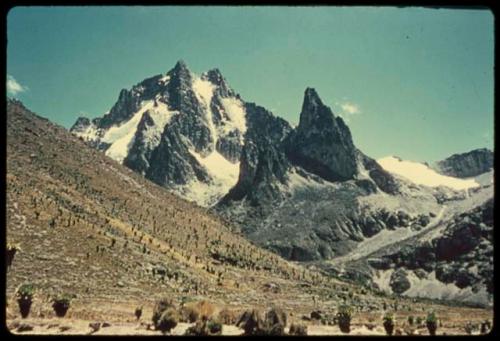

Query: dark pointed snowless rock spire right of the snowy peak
left=286, top=88, right=358, bottom=181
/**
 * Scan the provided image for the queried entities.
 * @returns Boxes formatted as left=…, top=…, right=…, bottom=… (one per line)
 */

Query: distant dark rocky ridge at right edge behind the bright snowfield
left=436, top=148, right=493, bottom=178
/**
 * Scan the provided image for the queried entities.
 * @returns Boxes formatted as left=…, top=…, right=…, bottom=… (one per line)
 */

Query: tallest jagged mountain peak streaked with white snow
left=71, top=61, right=246, bottom=206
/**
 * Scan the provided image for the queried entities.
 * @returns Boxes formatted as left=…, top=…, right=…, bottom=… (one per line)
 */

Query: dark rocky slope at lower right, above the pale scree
left=376, top=199, right=493, bottom=294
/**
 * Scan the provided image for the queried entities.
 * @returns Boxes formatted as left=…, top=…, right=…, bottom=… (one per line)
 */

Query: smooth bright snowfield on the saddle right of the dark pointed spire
left=377, top=156, right=479, bottom=190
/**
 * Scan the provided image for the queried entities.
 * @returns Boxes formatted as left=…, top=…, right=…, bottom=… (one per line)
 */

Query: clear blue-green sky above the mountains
left=7, top=6, right=494, bottom=161
